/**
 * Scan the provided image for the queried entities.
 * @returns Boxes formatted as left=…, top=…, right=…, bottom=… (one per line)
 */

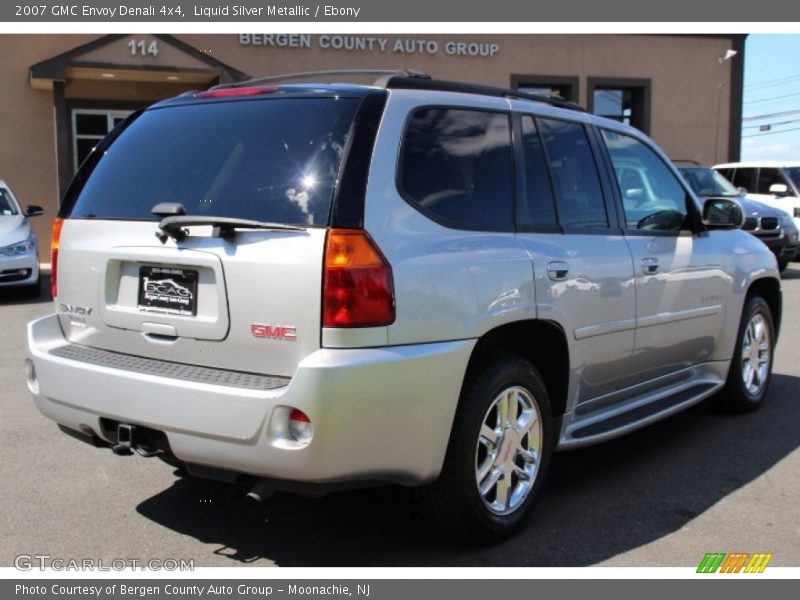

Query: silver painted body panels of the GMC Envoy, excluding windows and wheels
left=28, top=84, right=779, bottom=485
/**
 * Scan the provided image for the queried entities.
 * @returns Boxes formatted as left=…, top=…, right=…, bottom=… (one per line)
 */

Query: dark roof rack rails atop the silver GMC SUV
left=210, top=69, right=586, bottom=112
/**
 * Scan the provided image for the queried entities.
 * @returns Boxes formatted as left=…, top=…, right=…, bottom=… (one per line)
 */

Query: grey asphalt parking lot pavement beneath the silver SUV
left=0, top=270, right=800, bottom=567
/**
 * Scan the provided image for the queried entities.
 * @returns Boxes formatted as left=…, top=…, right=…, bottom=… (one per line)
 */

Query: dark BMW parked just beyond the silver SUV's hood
left=678, top=166, right=798, bottom=272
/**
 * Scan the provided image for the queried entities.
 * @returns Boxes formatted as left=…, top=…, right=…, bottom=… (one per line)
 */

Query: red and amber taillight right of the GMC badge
left=322, top=229, right=395, bottom=327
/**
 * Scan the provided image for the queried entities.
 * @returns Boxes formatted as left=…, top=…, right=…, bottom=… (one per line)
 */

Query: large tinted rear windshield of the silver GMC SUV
left=69, top=98, right=359, bottom=226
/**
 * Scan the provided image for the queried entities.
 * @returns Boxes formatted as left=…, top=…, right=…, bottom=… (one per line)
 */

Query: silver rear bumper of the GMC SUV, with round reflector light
left=28, top=315, right=474, bottom=485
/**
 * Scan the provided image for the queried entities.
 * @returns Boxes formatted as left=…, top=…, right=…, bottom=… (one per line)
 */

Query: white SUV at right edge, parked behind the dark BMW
left=713, top=161, right=800, bottom=227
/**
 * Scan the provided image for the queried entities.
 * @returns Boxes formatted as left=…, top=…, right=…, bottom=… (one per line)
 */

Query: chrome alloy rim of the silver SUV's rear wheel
left=475, top=386, right=542, bottom=515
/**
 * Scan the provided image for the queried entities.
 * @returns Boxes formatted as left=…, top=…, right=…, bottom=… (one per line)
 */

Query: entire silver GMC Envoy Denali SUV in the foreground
left=27, top=74, right=781, bottom=540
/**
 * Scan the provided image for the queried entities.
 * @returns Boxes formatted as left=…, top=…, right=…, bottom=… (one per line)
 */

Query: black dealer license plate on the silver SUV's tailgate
left=139, top=267, right=197, bottom=317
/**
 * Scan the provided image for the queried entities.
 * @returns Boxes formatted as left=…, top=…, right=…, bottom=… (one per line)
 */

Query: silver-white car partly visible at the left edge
left=0, top=179, right=44, bottom=296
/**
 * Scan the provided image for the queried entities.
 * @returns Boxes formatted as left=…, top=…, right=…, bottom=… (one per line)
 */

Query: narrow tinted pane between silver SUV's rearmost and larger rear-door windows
left=517, top=117, right=558, bottom=227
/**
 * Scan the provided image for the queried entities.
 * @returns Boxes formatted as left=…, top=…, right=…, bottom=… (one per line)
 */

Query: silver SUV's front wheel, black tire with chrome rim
left=717, top=296, right=775, bottom=413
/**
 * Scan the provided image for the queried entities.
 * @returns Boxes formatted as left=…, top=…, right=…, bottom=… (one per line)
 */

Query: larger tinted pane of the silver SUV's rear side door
left=539, top=119, right=608, bottom=228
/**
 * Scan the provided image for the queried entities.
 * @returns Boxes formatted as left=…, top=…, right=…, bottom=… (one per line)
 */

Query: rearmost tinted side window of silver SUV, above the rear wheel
left=399, top=108, right=514, bottom=229
